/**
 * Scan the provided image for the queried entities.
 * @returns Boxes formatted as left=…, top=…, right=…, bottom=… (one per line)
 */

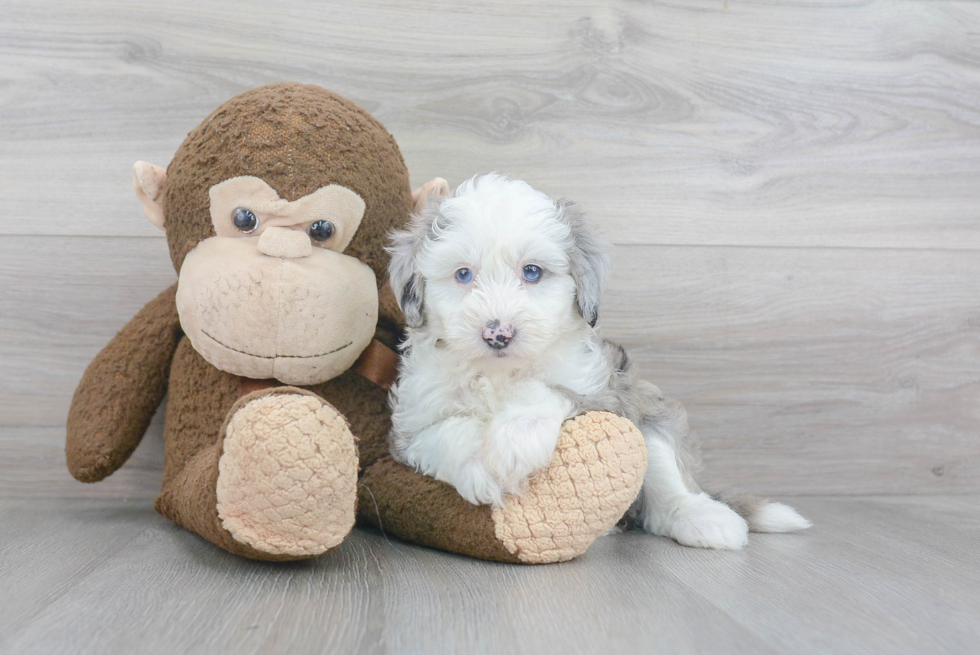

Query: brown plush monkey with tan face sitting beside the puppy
left=66, top=83, right=646, bottom=562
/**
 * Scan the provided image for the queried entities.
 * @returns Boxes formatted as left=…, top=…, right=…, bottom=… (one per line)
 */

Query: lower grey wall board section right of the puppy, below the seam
left=603, top=246, right=980, bottom=494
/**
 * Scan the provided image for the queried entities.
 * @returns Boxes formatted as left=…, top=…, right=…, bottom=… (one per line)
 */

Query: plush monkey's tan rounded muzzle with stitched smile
left=177, top=236, right=378, bottom=385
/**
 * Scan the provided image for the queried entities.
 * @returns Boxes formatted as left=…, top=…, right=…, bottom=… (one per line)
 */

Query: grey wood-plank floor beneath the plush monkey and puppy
left=0, top=496, right=980, bottom=655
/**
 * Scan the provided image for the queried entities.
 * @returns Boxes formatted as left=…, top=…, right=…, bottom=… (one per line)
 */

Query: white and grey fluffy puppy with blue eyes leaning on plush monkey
left=389, top=175, right=810, bottom=549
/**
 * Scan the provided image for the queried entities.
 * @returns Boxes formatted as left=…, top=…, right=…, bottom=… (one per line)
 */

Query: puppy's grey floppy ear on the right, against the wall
left=556, top=200, right=609, bottom=327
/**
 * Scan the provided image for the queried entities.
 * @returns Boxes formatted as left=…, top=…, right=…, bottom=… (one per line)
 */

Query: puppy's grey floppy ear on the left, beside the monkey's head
left=386, top=194, right=444, bottom=327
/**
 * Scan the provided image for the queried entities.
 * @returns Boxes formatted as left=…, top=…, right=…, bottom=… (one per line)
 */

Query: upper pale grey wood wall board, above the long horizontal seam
left=0, top=0, right=980, bottom=249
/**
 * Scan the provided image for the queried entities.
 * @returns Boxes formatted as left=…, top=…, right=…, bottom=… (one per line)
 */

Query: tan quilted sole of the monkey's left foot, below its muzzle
left=217, top=390, right=357, bottom=557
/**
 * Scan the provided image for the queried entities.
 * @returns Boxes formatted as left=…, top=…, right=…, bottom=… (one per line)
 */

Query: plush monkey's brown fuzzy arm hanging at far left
left=65, top=283, right=181, bottom=482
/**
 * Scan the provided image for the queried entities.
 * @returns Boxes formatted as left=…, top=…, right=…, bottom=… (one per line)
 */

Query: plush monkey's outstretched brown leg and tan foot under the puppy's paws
left=358, top=412, right=647, bottom=564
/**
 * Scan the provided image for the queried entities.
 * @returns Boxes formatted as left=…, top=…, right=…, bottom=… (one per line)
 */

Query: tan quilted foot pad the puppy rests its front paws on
left=492, top=412, right=647, bottom=564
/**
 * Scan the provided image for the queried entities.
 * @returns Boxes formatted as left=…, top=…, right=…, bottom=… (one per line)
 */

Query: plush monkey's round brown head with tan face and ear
left=133, top=83, right=412, bottom=385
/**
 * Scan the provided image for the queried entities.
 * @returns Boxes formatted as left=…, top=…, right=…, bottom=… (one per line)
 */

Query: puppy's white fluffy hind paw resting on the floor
left=666, top=494, right=749, bottom=550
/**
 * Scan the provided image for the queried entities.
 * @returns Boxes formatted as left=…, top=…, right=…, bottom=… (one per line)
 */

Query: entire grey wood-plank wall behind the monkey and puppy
left=0, top=0, right=980, bottom=497
